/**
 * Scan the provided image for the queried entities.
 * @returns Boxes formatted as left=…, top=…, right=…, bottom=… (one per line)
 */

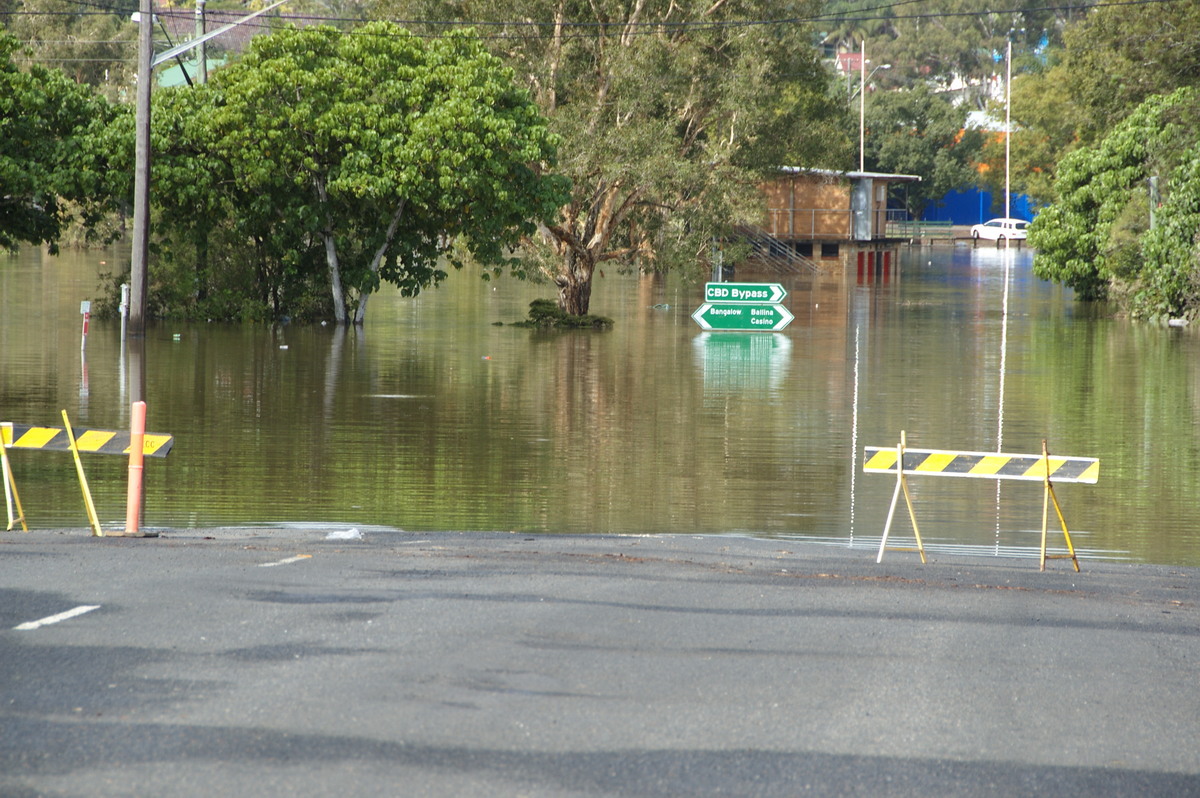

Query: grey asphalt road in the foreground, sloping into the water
left=0, top=526, right=1200, bottom=798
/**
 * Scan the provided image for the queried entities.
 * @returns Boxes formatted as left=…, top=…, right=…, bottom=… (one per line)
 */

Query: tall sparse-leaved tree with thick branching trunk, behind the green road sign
left=380, top=0, right=844, bottom=314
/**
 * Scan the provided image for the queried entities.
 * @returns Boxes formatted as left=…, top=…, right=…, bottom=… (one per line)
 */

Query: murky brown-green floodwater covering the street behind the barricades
left=0, top=247, right=1200, bottom=568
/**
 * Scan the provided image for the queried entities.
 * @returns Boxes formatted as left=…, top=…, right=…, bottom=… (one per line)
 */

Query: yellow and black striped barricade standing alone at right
left=863, top=432, right=1100, bottom=571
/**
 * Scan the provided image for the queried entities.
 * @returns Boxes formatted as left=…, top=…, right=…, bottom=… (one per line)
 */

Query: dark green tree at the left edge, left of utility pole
left=0, top=34, right=112, bottom=252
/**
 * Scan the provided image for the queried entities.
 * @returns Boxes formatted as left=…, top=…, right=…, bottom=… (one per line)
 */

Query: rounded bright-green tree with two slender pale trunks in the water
left=201, top=23, right=565, bottom=324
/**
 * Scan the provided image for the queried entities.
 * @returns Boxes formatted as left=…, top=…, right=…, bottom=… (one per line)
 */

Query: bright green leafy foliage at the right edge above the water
left=1030, top=89, right=1200, bottom=317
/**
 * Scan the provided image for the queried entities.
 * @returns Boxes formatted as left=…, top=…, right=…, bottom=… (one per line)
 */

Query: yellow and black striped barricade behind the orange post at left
left=0, top=410, right=175, bottom=536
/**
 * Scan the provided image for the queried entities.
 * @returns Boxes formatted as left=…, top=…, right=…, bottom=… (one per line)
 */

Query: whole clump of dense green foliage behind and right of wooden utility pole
left=87, top=23, right=566, bottom=323
